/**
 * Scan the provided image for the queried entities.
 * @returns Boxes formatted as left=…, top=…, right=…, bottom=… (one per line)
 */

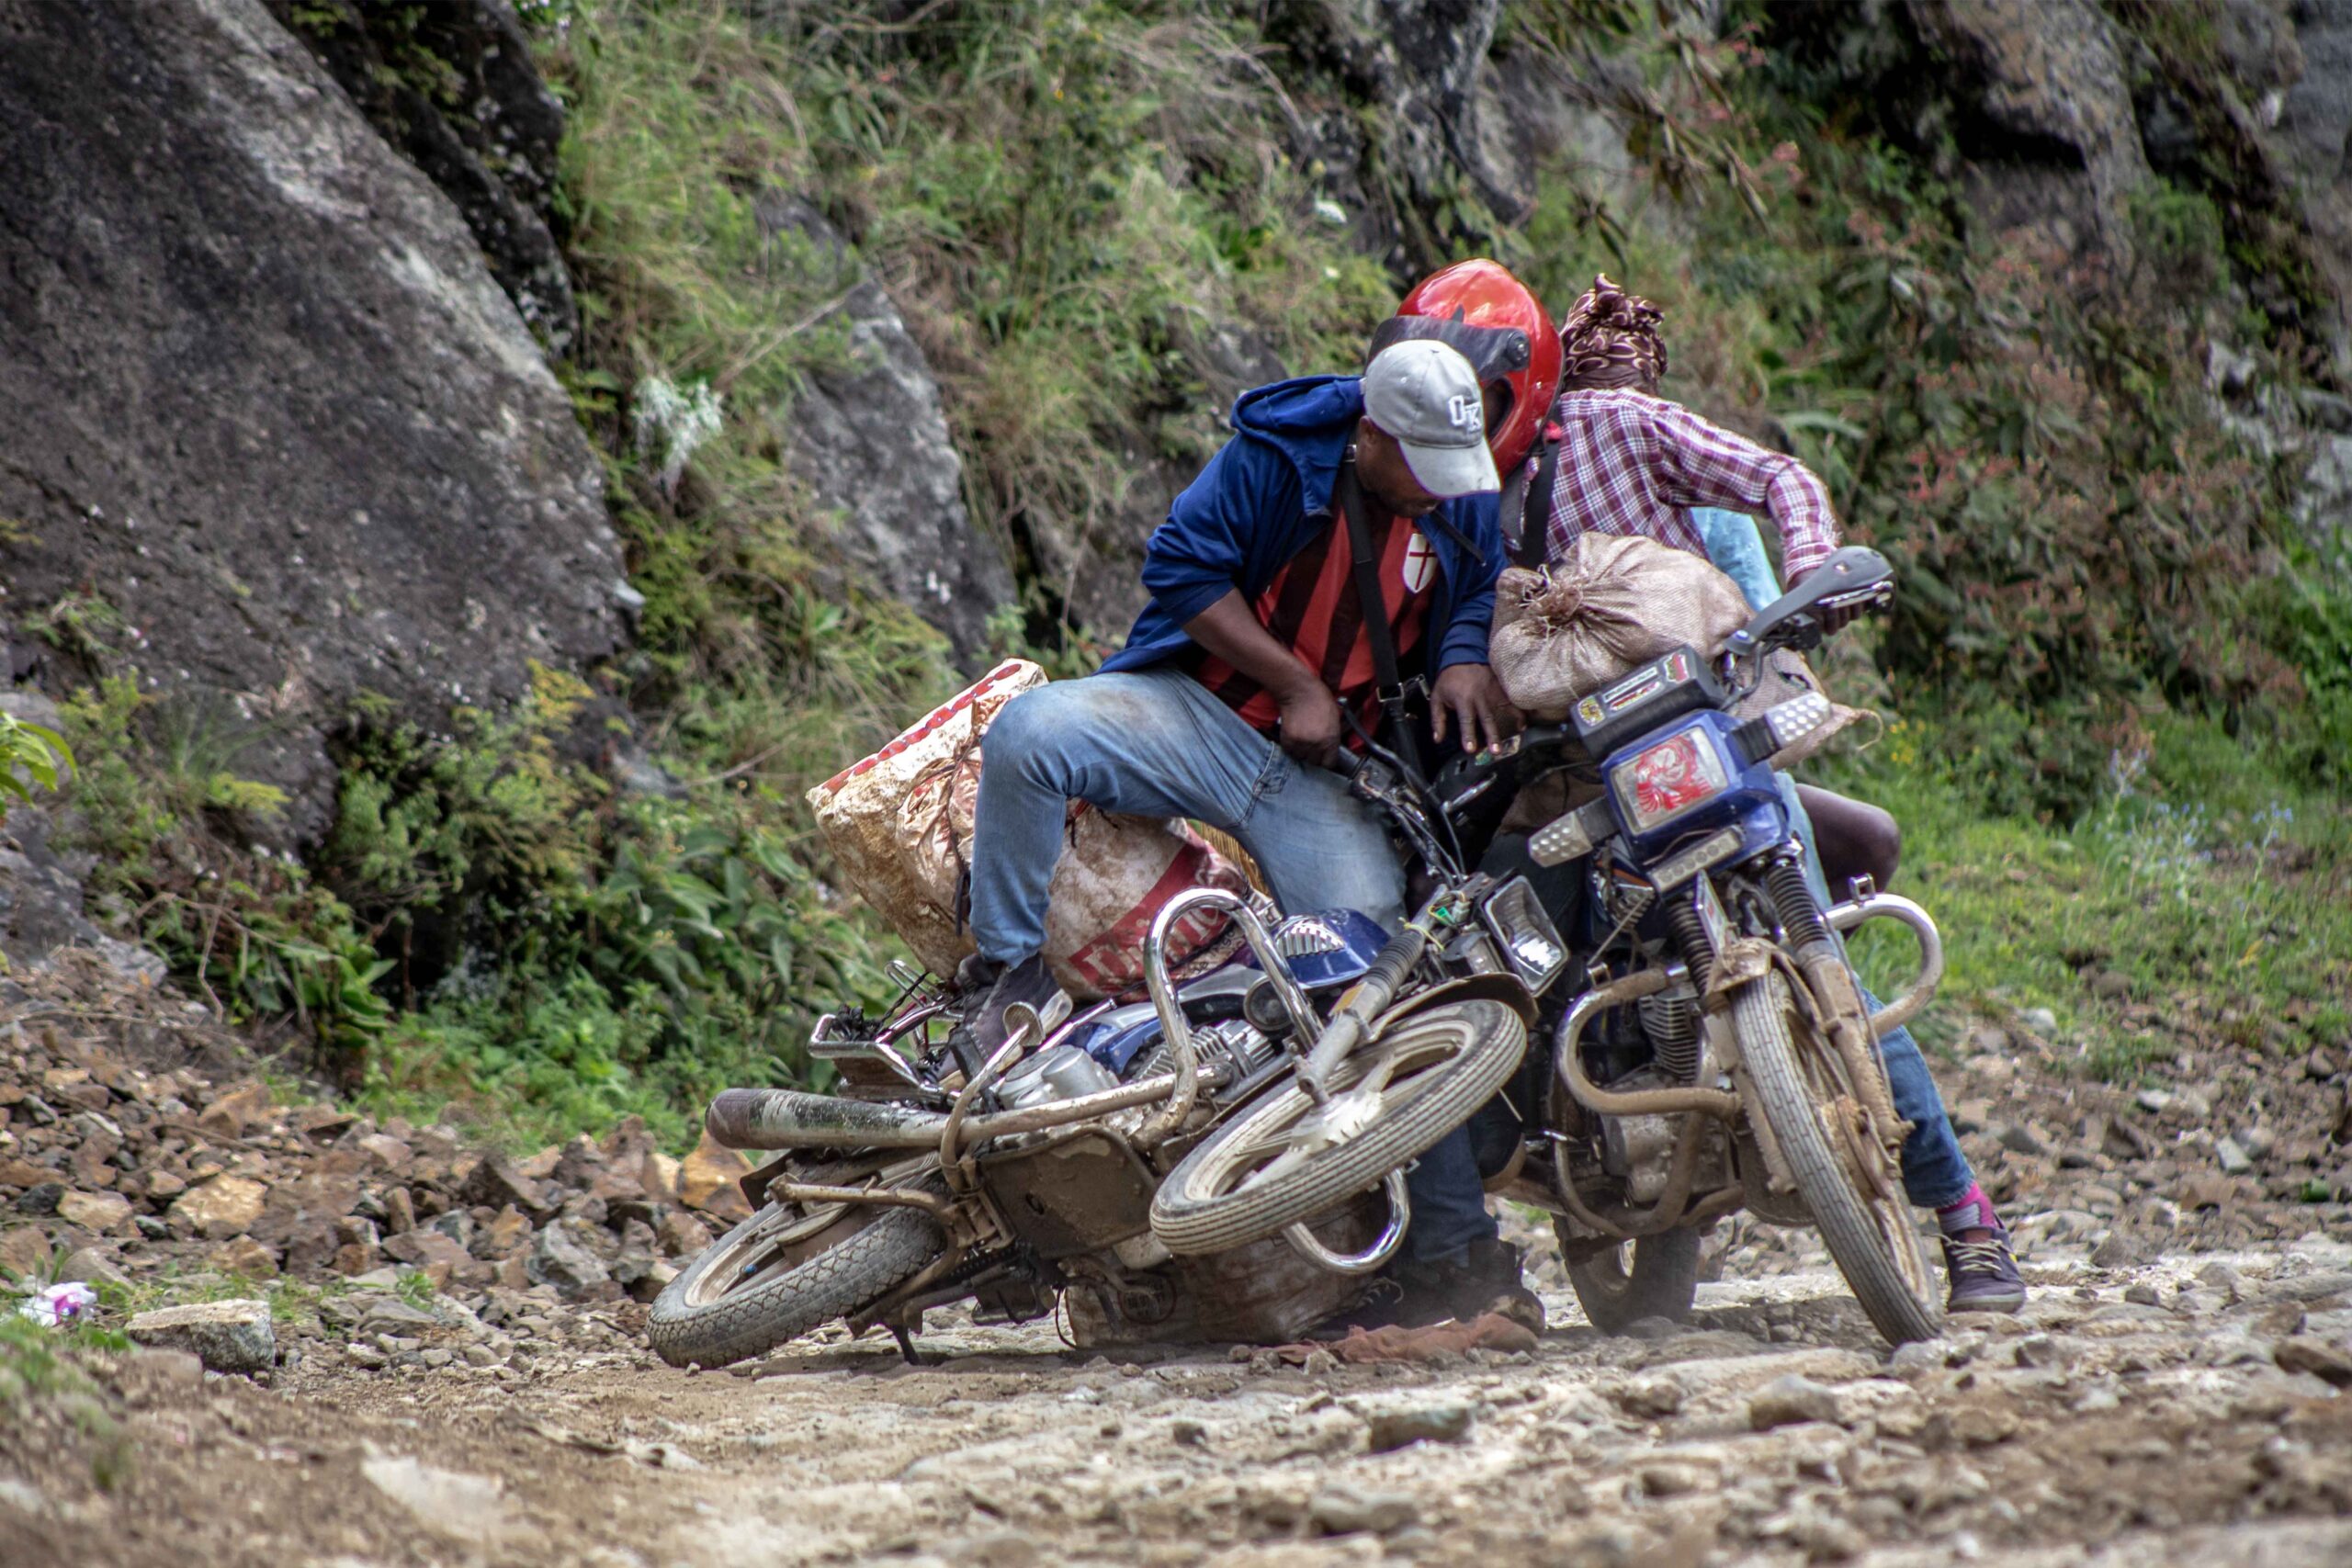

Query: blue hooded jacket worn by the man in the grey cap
left=1103, top=376, right=1503, bottom=674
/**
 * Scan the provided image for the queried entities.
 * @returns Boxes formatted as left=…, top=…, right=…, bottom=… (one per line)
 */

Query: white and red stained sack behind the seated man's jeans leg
left=809, top=659, right=1249, bottom=999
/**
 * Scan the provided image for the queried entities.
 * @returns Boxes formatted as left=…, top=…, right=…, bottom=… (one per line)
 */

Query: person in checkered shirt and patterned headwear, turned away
left=1510, top=275, right=2025, bottom=1312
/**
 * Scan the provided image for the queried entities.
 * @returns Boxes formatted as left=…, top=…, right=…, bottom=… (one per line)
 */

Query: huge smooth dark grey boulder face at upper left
left=0, top=0, right=623, bottom=841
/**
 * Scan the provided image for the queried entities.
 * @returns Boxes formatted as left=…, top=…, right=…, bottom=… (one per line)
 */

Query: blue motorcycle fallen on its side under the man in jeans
left=647, top=841, right=1566, bottom=1366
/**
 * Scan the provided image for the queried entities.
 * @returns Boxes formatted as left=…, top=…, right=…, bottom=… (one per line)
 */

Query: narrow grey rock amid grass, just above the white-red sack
left=757, top=197, right=1013, bottom=665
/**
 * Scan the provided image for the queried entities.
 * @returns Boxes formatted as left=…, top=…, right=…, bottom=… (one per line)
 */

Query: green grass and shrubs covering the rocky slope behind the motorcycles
left=37, top=0, right=2352, bottom=1143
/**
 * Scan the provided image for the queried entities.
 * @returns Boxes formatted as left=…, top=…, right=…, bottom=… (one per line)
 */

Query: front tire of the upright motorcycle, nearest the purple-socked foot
left=1731, top=971, right=1943, bottom=1345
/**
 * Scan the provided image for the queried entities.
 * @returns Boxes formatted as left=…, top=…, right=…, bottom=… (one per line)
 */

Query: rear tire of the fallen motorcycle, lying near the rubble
left=644, top=1203, right=948, bottom=1368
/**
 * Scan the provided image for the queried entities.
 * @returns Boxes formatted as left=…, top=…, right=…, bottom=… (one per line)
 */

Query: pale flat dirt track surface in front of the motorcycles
left=0, top=1236, right=2352, bottom=1568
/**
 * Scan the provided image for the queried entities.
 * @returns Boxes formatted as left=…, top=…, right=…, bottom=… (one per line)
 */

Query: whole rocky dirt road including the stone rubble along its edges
left=14, top=959, right=2352, bottom=1568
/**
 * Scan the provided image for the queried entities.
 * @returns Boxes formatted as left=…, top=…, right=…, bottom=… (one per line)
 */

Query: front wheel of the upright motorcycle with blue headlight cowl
left=1731, top=971, right=1943, bottom=1345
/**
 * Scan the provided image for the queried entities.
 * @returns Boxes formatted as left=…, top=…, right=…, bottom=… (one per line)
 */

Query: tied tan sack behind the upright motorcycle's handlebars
left=1488, top=534, right=1860, bottom=764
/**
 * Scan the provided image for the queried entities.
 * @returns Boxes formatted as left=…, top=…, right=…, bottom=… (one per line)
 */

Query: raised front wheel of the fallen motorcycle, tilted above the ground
left=1152, top=1001, right=1526, bottom=1258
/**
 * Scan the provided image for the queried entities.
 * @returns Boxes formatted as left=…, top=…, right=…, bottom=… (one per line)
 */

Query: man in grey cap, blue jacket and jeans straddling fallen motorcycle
left=957, top=339, right=1550, bottom=1316
